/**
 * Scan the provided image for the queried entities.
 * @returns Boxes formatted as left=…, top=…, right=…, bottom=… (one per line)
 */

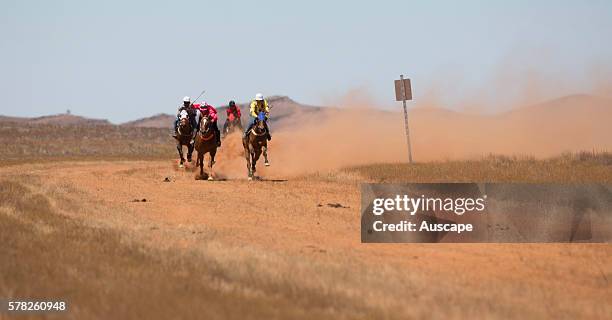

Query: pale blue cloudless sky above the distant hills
left=0, top=0, right=612, bottom=122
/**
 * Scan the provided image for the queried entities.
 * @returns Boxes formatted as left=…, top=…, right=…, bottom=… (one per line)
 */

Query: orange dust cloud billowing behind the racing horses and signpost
left=212, top=82, right=612, bottom=178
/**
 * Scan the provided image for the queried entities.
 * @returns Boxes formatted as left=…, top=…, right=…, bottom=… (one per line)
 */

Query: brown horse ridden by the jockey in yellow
left=242, top=112, right=270, bottom=180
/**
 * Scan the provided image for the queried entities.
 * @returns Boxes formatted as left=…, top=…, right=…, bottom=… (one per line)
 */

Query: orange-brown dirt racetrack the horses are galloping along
left=0, top=161, right=612, bottom=318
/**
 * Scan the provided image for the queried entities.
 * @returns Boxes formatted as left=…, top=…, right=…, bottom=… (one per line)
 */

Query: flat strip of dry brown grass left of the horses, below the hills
left=0, top=122, right=176, bottom=165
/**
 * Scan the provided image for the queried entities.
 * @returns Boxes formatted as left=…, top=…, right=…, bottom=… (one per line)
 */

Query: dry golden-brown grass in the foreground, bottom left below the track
left=0, top=179, right=396, bottom=319
